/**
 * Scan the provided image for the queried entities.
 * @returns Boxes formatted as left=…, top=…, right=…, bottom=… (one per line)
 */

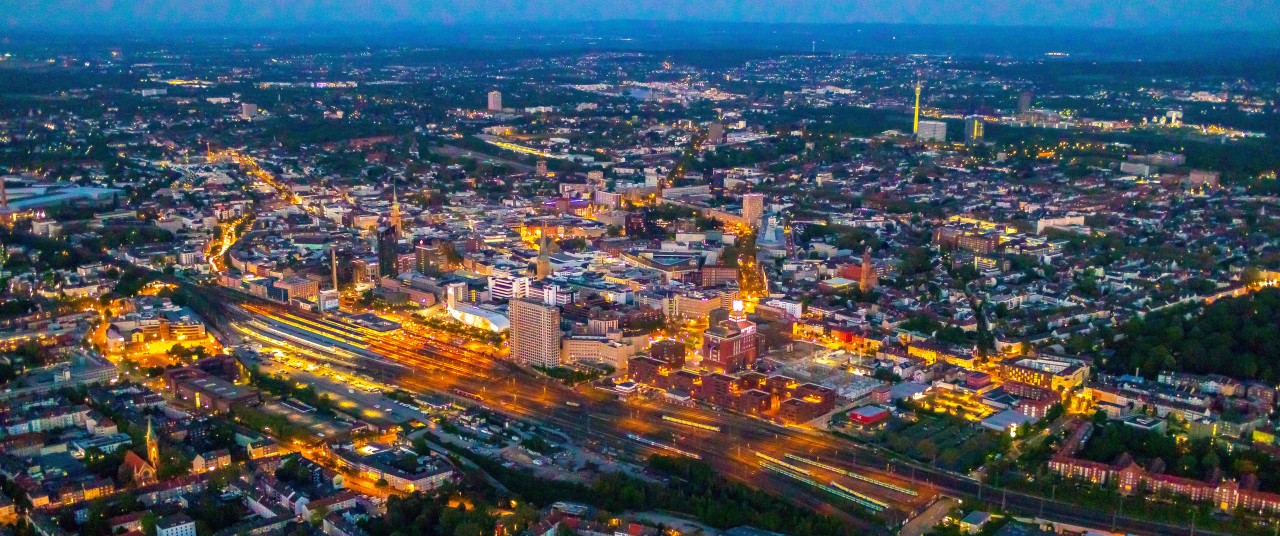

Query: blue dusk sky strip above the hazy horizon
left=0, top=0, right=1280, bottom=29
